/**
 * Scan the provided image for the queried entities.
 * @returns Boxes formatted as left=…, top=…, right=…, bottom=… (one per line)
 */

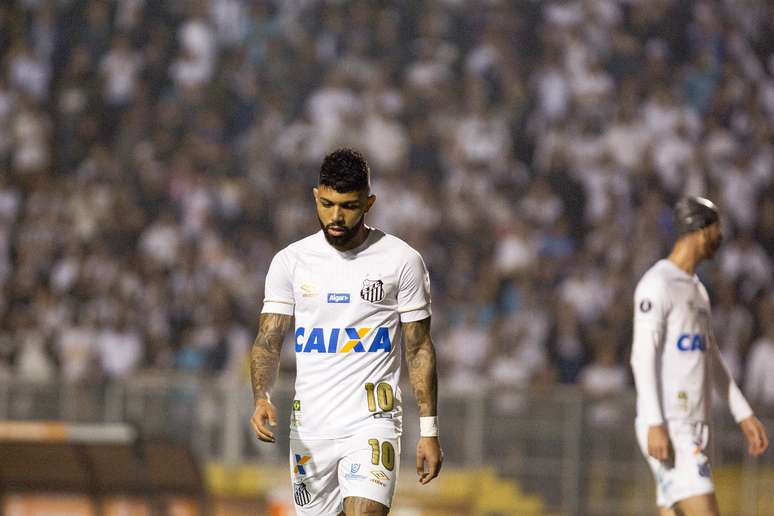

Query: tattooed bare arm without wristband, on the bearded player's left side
left=250, top=314, right=293, bottom=401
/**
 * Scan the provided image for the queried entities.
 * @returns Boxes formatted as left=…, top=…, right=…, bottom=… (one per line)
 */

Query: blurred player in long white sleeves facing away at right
left=631, top=197, right=768, bottom=516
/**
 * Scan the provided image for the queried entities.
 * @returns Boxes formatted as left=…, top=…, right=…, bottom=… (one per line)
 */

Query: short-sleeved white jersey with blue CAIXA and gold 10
left=263, top=229, right=431, bottom=439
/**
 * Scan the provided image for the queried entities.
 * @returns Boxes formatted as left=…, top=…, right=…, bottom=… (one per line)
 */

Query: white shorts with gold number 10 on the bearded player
left=290, top=431, right=400, bottom=516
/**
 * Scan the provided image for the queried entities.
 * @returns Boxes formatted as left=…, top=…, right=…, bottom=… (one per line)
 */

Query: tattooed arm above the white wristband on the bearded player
left=402, top=317, right=438, bottom=416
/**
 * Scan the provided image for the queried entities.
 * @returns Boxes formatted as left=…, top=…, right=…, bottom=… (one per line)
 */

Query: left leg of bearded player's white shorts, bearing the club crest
left=290, top=439, right=341, bottom=516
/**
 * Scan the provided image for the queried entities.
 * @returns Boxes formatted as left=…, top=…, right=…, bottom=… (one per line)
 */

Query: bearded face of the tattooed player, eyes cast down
left=314, top=185, right=376, bottom=250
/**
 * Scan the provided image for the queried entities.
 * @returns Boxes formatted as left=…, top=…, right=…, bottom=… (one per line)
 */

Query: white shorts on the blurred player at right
left=635, top=421, right=715, bottom=507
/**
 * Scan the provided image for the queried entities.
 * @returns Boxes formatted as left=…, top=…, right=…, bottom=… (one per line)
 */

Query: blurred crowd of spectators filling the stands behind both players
left=0, top=0, right=774, bottom=420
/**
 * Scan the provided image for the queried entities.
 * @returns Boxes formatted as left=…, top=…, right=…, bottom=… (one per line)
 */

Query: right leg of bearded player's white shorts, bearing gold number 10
left=339, top=433, right=400, bottom=514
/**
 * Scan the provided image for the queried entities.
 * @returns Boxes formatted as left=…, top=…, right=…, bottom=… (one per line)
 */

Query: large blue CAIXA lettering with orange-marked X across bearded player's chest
left=296, top=326, right=392, bottom=353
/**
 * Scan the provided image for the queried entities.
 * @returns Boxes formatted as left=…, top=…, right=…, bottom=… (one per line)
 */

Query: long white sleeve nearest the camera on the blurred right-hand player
left=631, top=278, right=669, bottom=426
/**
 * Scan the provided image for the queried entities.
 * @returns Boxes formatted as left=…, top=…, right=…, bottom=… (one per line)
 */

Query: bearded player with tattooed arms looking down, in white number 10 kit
left=251, top=149, right=443, bottom=516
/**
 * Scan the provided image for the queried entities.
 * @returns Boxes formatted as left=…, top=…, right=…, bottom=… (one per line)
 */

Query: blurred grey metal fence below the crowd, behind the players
left=0, top=375, right=774, bottom=516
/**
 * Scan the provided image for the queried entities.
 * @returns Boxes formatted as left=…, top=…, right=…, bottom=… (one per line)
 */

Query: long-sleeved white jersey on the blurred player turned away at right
left=631, top=259, right=752, bottom=425
